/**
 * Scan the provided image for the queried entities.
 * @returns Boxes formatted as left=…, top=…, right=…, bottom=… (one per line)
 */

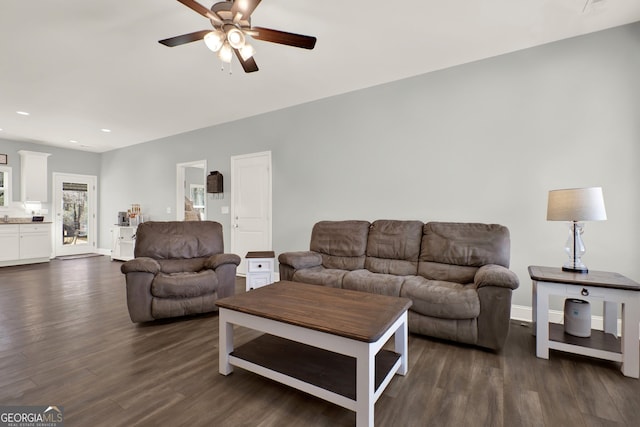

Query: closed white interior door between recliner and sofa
left=231, top=151, right=272, bottom=275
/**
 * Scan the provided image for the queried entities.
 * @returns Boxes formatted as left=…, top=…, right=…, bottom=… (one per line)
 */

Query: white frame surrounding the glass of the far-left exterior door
left=51, top=172, right=98, bottom=257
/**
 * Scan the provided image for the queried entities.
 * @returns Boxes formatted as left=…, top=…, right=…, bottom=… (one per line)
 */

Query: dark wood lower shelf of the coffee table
left=229, top=334, right=400, bottom=400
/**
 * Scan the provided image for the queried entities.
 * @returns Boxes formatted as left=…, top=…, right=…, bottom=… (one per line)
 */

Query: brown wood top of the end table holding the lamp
left=529, top=265, right=640, bottom=291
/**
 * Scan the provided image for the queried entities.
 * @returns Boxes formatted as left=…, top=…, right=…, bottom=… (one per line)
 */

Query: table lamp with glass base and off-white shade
left=547, top=187, right=607, bottom=273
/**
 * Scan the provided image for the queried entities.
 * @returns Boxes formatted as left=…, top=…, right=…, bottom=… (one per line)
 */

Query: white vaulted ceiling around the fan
left=0, top=0, right=640, bottom=152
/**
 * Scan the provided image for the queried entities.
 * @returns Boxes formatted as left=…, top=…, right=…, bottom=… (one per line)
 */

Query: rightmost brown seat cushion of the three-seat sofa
left=400, top=276, right=480, bottom=319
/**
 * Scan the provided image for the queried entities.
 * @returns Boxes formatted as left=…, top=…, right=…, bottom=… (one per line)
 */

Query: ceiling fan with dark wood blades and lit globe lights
left=158, top=0, right=316, bottom=73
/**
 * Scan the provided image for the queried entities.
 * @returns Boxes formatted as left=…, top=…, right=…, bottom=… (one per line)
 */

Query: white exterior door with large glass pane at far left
left=52, top=173, right=98, bottom=256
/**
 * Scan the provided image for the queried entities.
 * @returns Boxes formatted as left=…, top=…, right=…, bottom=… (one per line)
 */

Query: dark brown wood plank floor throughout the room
left=0, top=257, right=640, bottom=427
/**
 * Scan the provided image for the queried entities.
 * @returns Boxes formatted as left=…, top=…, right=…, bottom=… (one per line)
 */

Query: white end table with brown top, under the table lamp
left=529, top=266, right=640, bottom=378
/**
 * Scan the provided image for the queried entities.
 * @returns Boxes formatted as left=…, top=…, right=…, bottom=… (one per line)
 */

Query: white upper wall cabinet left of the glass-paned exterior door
left=18, top=150, right=51, bottom=202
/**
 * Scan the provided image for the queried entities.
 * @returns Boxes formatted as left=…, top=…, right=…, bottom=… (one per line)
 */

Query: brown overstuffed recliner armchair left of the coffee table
left=121, top=221, right=240, bottom=322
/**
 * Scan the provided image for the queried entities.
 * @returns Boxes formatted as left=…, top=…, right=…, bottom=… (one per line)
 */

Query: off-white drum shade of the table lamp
left=547, top=187, right=607, bottom=221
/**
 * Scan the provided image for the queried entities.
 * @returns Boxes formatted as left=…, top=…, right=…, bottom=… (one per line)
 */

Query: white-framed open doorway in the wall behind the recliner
left=176, top=160, right=207, bottom=221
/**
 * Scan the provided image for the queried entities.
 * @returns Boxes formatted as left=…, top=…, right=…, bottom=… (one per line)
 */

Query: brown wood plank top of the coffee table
left=216, top=281, right=411, bottom=342
